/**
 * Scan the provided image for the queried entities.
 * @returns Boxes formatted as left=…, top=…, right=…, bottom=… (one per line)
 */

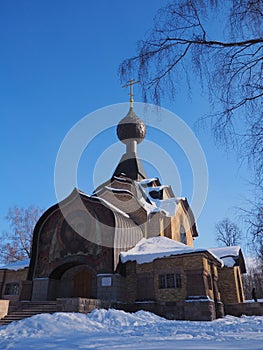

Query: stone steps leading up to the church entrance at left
left=0, top=301, right=57, bottom=326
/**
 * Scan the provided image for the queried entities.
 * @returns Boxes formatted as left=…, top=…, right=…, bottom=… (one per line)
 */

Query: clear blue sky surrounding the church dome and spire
left=0, top=0, right=254, bottom=252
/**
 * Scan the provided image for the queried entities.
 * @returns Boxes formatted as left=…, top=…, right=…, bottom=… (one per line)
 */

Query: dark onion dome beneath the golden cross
left=117, top=107, right=146, bottom=143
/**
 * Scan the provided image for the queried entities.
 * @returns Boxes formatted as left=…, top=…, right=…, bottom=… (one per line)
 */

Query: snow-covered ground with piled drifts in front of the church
left=0, top=310, right=263, bottom=350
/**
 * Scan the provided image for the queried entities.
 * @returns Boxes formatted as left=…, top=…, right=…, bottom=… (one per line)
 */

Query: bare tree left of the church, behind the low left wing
left=0, top=206, right=43, bottom=263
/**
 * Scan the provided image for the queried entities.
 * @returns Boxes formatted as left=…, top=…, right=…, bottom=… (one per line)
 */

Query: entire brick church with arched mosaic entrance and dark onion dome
left=0, top=90, right=248, bottom=320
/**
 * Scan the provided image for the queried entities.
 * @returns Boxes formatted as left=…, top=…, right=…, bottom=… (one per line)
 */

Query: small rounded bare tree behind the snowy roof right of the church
left=215, top=218, right=242, bottom=247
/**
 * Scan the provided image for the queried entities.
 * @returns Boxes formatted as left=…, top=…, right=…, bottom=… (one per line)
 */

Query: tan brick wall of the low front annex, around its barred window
left=123, top=253, right=220, bottom=303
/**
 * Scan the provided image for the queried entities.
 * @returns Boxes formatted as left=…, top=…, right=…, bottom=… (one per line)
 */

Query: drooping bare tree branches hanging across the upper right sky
left=120, top=0, right=263, bottom=183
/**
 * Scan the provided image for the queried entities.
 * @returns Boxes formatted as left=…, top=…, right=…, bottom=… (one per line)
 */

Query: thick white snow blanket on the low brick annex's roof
left=120, top=236, right=210, bottom=264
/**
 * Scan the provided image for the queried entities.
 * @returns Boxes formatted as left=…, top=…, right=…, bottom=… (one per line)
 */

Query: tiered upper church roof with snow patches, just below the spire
left=93, top=174, right=198, bottom=237
